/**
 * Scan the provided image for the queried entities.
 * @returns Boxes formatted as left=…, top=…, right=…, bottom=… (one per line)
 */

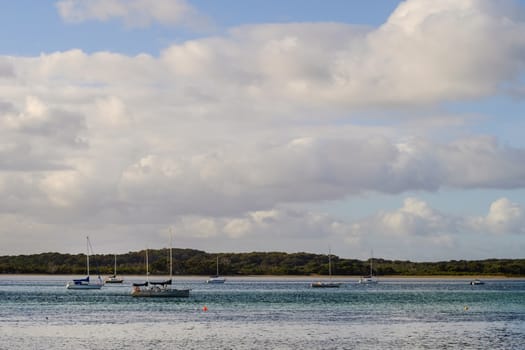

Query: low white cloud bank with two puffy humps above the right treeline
left=350, top=197, right=525, bottom=260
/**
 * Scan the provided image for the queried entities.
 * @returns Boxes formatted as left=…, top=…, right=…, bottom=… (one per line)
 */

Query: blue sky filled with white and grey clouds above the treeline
left=0, top=0, right=525, bottom=261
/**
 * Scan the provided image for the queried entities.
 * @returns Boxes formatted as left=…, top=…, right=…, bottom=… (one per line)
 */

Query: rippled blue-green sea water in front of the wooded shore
left=0, top=275, right=525, bottom=349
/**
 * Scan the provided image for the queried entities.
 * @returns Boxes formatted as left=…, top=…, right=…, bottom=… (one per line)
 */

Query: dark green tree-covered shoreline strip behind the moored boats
left=0, top=249, right=525, bottom=276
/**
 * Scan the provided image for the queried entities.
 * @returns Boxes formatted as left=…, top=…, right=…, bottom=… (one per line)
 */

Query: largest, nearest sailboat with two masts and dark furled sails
left=131, top=238, right=190, bottom=298
